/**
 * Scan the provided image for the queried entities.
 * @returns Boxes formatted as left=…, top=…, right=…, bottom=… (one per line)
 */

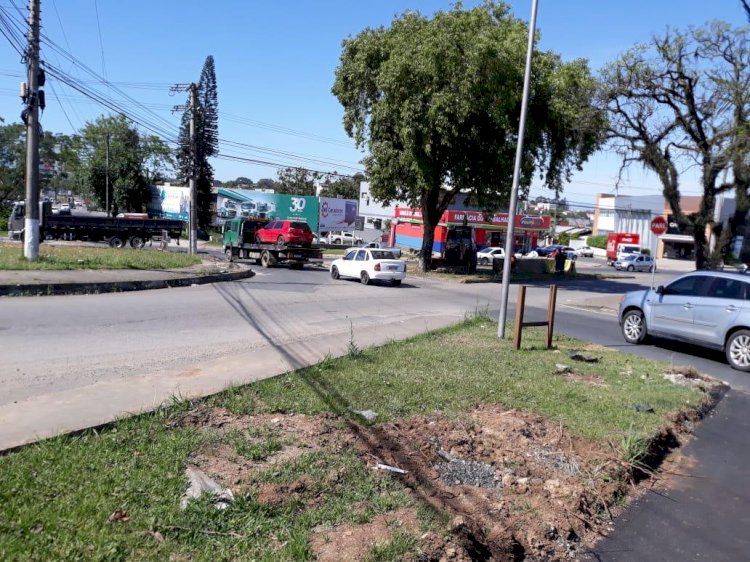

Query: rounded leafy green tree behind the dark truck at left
left=74, top=115, right=171, bottom=214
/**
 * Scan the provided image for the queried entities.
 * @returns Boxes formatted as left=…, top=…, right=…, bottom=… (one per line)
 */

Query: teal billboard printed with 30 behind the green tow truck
left=216, top=188, right=318, bottom=232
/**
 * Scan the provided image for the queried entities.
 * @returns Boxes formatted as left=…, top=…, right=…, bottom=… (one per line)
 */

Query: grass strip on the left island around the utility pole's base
left=0, top=242, right=201, bottom=270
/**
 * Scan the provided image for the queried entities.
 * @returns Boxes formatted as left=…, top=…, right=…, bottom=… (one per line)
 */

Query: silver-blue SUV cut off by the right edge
left=619, top=271, right=750, bottom=371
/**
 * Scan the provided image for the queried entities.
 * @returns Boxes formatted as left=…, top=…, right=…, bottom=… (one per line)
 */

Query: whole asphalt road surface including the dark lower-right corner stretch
left=0, top=260, right=750, bottom=561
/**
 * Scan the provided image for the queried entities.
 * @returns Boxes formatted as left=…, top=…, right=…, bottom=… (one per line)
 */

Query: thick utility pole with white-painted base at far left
left=23, top=0, right=41, bottom=261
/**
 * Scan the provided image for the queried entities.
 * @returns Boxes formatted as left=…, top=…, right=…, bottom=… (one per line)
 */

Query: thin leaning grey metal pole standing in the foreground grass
left=497, top=0, right=537, bottom=338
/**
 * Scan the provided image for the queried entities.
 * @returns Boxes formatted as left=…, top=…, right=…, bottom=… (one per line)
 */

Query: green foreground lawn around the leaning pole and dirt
left=0, top=318, right=706, bottom=561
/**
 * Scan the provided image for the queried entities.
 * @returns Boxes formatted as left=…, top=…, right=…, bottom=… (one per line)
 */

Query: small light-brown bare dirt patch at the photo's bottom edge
left=310, top=508, right=419, bottom=562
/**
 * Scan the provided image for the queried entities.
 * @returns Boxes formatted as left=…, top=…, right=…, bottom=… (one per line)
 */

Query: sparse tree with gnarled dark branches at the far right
left=600, top=22, right=750, bottom=268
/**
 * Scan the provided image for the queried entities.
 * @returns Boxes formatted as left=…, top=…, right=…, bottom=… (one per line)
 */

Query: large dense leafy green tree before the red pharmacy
left=332, top=1, right=604, bottom=269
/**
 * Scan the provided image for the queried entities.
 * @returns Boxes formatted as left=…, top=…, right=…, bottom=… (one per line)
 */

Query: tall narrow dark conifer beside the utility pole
left=177, top=55, right=219, bottom=230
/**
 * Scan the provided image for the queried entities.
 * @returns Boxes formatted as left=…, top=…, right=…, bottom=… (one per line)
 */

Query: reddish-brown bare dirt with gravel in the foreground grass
left=175, top=402, right=700, bottom=561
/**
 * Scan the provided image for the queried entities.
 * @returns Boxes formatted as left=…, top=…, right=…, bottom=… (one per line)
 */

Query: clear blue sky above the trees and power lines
left=0, top=0, right=747, bottom=204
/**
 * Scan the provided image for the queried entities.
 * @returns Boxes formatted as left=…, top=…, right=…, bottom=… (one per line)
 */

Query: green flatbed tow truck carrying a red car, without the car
left=223, top=218, right=323, bottom=269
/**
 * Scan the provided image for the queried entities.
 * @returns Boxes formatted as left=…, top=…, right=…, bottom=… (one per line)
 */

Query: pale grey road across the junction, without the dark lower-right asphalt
left=0, top=260, right=750, bottom=447
